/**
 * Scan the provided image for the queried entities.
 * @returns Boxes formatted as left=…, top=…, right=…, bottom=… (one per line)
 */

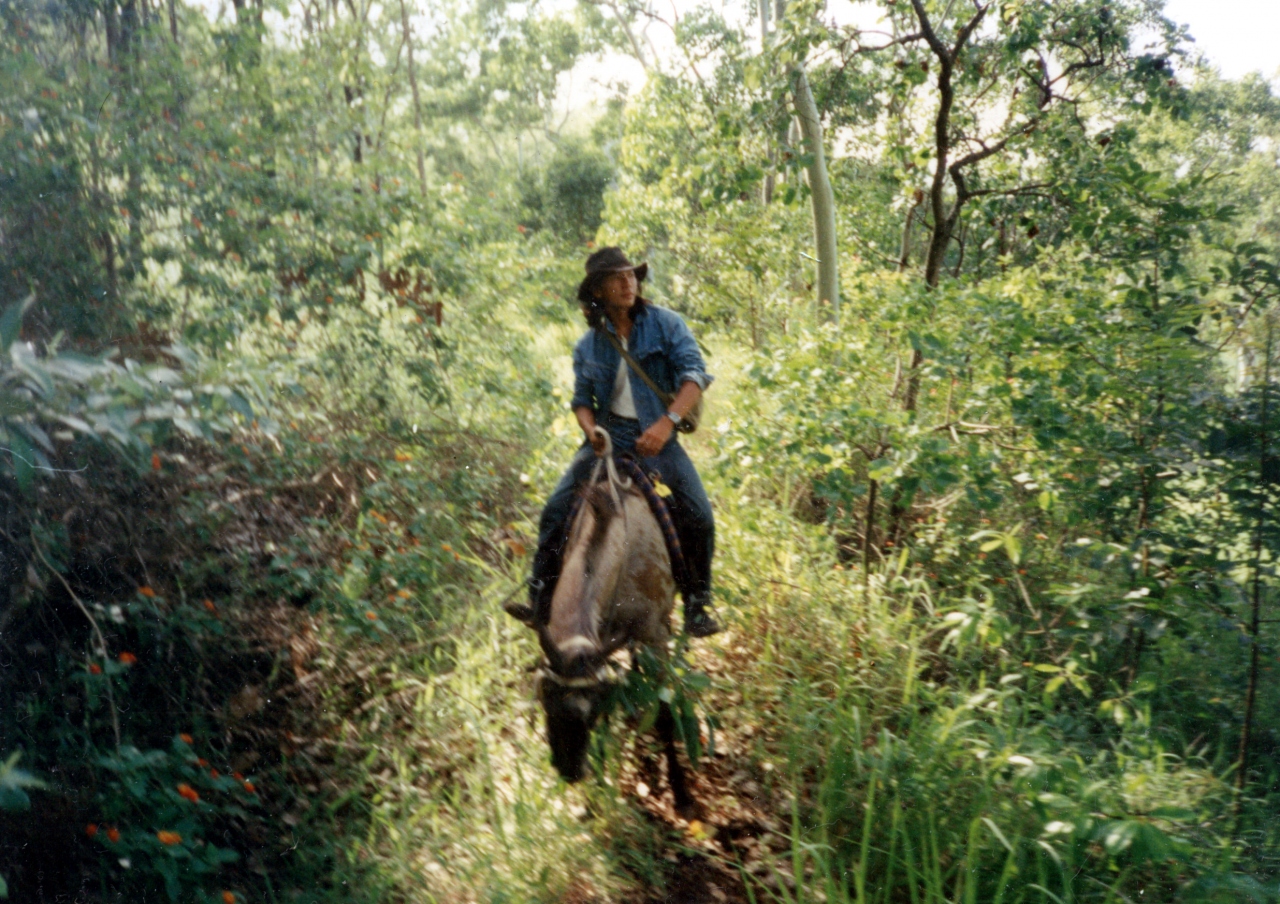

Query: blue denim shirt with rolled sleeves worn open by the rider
left=570, top=305, right=714, bottom=430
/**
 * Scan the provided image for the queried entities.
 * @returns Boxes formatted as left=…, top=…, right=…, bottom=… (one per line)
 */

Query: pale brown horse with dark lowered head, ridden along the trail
left=508, top=426, right=692, bottom=811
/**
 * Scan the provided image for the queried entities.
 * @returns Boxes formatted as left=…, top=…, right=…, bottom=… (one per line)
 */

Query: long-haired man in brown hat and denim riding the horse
left=529, top=247, right=721, bottom=638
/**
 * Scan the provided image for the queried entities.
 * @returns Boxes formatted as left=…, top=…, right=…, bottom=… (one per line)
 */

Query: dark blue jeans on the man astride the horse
left=530, top=417, right=716, bottom=615
